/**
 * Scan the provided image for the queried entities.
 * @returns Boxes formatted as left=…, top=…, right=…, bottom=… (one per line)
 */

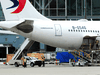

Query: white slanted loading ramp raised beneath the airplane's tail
left=8, top=38, right=34, bottom=64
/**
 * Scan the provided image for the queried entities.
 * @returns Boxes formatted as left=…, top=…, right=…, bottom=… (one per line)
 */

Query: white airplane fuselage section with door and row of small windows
left=26, top=21, right=100, bottom=49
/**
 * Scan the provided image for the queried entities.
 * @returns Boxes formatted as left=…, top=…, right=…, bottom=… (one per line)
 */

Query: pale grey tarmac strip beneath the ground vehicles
left=0, top=63, right=100, bottom=75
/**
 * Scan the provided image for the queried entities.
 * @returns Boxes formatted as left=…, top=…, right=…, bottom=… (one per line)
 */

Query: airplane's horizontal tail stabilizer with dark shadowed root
left=0, top=20, right=34, bottom=33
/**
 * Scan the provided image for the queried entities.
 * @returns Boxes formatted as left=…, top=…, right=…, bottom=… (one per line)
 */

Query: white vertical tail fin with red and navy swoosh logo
left=0, top=0, right=50, bottom=21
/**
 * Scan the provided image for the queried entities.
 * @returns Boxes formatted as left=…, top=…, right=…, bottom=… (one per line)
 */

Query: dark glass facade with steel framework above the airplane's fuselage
left=30, top=0, right=100, bottom=20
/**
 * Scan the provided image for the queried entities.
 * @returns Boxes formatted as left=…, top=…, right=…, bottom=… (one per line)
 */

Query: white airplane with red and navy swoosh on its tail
left=0, top=0, right=100, bottom=50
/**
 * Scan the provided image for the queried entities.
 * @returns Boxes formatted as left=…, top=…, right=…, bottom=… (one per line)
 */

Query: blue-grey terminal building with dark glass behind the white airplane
left=0, top=0, right=100, bottom=60
